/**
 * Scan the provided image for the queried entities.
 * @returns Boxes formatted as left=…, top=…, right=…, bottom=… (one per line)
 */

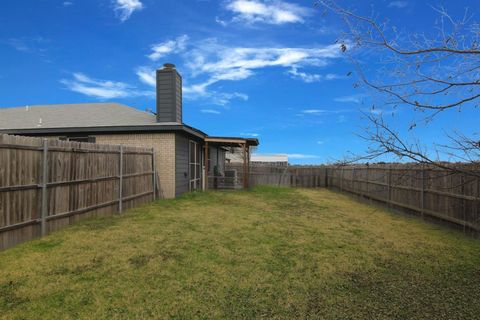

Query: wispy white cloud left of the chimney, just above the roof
left=61, top=73, right=153, bottom=99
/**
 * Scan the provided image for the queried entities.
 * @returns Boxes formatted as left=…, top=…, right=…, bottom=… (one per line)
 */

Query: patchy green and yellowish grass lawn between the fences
left=0, top=187, right=480, bottom=319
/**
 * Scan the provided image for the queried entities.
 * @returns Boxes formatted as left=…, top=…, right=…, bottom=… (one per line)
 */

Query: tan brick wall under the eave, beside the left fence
left=95, top=133, right=175, bottom=198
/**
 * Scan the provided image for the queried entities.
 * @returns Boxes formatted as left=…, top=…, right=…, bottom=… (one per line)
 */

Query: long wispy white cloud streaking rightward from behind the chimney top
left=136, top=35, right=341, bottom=105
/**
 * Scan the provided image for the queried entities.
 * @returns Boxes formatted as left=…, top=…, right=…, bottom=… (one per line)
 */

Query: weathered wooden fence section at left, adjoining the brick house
left=0, top=135, right=156, bottom=250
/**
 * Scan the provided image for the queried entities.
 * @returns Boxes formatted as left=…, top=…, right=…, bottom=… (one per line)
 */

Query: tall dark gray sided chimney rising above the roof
left=157, top=63, right=182, bottom=123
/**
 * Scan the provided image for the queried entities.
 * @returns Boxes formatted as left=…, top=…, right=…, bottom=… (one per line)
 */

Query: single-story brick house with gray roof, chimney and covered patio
left=0, top=64, right=259, bottom=198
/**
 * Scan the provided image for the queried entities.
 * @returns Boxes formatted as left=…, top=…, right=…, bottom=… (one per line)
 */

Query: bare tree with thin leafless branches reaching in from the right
left=317, top=0, right=480, bottom=175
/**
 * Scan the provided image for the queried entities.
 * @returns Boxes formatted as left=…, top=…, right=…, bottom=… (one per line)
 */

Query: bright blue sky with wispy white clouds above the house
left=0, top=0, right=480, bottom=163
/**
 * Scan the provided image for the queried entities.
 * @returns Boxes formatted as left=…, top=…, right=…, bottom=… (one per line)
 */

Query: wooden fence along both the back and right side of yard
left=227, top=164, right=480, bottom=233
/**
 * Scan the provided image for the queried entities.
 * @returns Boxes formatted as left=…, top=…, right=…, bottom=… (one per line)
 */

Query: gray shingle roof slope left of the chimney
left=0, top=103, right=179, bottom=130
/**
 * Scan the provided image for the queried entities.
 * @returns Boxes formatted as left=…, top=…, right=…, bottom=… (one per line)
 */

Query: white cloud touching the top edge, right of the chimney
left=225, top=0, right=311, bottom=25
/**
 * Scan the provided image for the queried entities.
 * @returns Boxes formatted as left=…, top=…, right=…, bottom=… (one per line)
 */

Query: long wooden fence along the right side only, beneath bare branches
left=327, top=164, right=480, bottom=232
